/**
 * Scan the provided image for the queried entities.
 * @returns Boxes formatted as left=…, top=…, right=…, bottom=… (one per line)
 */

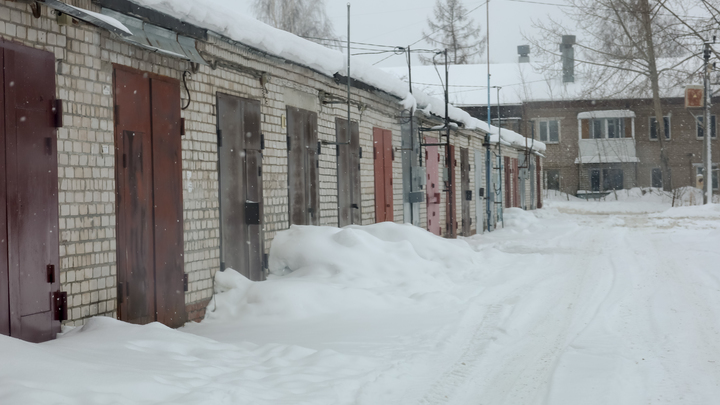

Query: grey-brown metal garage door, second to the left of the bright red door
left=287, top=107, right=320, bottom=225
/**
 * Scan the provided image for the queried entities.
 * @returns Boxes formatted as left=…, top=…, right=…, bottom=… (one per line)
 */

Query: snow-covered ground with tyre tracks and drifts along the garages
left=0, top=194, right=720, bottom=405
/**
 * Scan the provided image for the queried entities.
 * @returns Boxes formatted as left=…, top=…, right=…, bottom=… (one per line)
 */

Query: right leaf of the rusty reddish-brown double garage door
left=150, top=76, right=187, bottom=328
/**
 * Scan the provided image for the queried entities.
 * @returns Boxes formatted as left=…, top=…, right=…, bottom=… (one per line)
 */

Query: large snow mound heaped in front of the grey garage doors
left=208, top=222, right=480, bottom=321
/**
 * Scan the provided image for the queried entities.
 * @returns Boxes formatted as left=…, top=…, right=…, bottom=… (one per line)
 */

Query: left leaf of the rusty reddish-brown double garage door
left=115, top=69, right=155, bottom=324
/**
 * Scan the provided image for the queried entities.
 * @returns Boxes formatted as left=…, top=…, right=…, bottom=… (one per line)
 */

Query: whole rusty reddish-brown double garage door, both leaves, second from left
left=114, top=66, right=186, bottom=327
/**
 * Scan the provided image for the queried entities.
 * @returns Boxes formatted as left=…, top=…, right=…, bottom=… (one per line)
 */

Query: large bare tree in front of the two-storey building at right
left=527, top=0, right=709, bottom=191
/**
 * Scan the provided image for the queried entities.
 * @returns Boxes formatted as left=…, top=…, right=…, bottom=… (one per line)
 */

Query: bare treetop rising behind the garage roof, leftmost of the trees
left=253, top=0, right=340, bottom=48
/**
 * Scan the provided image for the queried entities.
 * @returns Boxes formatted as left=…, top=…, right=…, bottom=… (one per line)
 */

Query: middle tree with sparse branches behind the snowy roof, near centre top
left=420, top=0, right=486, bottom=65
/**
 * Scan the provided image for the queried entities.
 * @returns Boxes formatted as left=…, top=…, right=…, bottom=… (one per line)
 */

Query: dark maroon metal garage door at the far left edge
left=0, top=43, right=63, bottom=342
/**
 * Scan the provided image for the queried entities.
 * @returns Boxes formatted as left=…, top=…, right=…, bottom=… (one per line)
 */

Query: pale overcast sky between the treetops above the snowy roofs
left=233, top=0, right=564, bottom=67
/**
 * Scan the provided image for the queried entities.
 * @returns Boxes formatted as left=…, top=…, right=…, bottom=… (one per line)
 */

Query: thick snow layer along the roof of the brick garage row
left=132, top=0, right=545, bottom=151
